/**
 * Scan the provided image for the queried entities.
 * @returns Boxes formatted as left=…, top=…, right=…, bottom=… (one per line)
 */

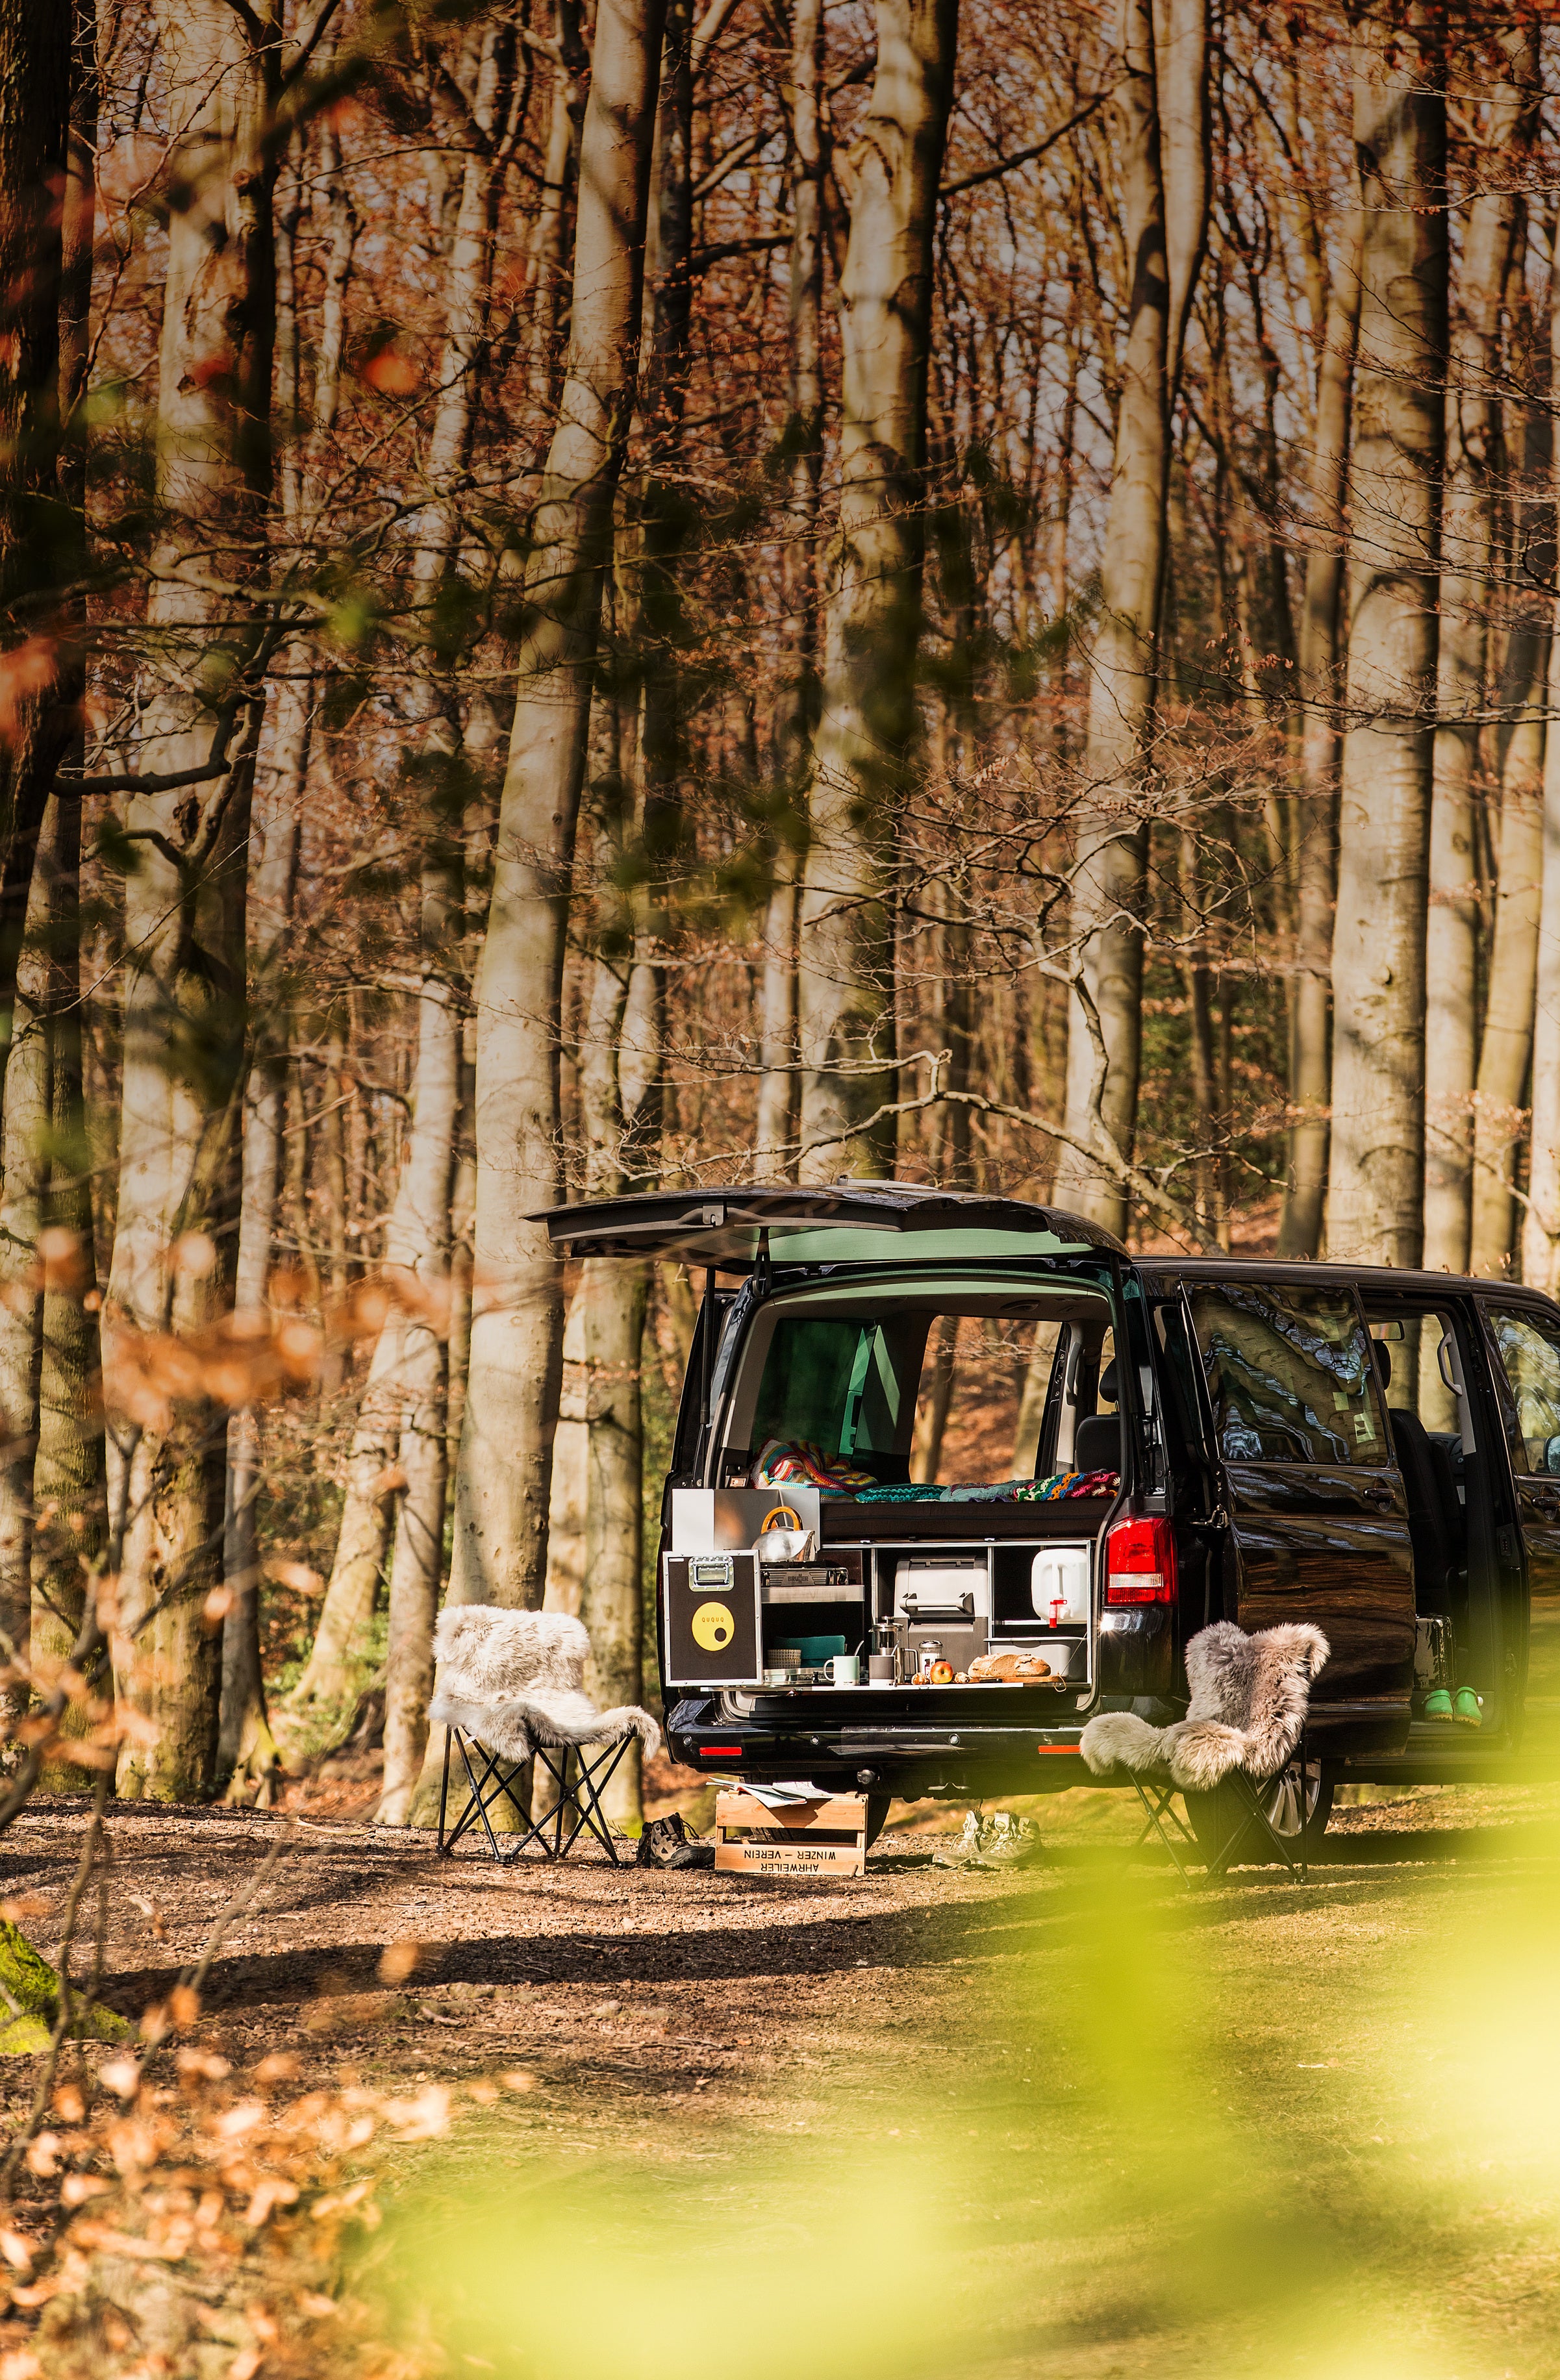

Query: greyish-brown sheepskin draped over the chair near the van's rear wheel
left=1079, top=1621, right=1329, bottom=1792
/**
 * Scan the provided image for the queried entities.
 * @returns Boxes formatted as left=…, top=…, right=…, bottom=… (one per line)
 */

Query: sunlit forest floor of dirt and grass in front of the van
left=0, top=1787, right=1560, bottom=2380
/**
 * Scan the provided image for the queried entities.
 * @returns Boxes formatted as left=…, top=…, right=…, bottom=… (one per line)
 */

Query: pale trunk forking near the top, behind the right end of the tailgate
left=1055, top=0, right=1207, bottom=1233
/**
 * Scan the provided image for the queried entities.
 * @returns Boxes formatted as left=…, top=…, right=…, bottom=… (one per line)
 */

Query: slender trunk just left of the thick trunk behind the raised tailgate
left=753, top=0, right=824, bottom=1181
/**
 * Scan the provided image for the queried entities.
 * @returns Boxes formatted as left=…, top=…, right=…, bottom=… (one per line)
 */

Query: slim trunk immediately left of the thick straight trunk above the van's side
left=1279, top=210, right=1365, bottom=1257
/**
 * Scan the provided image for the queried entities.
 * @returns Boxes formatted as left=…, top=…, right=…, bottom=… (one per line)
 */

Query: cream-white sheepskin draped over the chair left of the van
left=429, top=1604, right=660, bottom=1761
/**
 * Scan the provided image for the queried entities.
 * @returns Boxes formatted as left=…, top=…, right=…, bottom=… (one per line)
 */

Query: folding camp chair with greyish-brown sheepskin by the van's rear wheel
left=1079, top=1621, right=1327, bottom=1883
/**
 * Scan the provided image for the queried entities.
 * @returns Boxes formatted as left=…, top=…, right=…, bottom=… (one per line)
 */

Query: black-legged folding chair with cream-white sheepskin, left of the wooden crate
left=429, top=1604, right=660, bottom=1866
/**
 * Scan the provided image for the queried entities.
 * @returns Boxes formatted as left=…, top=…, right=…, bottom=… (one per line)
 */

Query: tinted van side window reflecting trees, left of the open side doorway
left=1191, top=1281, right=1391, bottom=1464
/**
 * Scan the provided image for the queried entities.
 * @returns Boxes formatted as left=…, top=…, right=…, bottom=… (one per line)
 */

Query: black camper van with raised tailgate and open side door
left=547, top=1183, right=1560, bottom=1833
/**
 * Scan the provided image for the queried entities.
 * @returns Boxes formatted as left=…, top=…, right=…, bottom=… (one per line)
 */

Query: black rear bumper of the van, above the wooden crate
left=667, top=1694, right=1098, bottom=1801
